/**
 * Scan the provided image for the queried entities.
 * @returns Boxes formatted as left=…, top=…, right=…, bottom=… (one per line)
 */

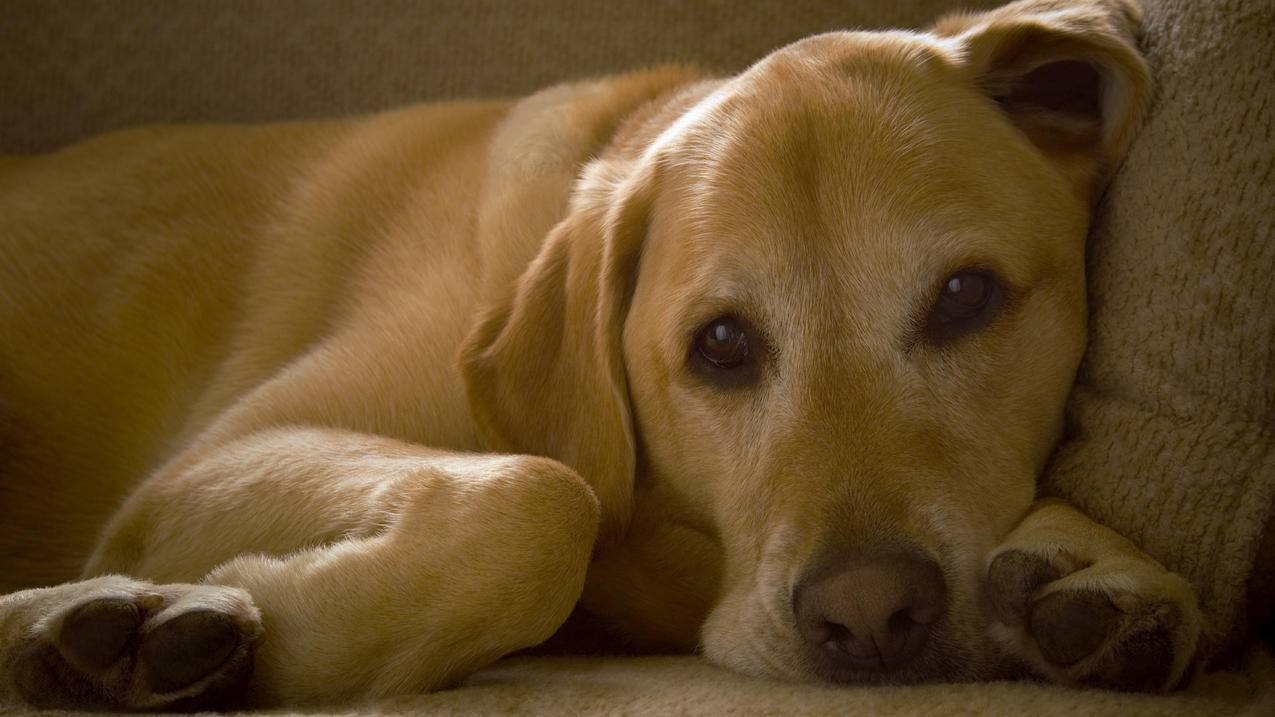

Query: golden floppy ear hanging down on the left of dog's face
left=460, top=159, right=650, bottom=537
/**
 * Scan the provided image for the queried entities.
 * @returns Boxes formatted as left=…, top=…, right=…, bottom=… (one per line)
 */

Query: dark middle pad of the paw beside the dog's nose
left=1031, top=591, right=1119, bottom=667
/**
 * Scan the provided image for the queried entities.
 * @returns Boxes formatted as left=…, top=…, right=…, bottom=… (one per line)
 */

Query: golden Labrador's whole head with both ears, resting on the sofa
left=462, top=1, right=1149, bottom=681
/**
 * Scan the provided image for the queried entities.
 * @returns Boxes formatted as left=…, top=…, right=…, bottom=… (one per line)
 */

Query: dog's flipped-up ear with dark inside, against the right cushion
left=933, top=0, right=1151, bottom=194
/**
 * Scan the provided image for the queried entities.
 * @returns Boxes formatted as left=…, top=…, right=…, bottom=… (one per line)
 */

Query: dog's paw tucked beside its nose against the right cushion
left=987, top=500, right=1204, bottom=691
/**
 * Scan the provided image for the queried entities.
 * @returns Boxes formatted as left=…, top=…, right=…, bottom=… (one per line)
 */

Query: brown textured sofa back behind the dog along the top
left=0, top=0, right=1000, bottom=152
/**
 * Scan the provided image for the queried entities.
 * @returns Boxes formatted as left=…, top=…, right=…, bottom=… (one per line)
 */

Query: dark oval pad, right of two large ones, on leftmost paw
left=140, top=610, right=241, bottom=693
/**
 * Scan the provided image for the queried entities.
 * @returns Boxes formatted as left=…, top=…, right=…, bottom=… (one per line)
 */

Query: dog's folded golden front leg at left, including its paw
left=0, top=429, right=598, bottom=708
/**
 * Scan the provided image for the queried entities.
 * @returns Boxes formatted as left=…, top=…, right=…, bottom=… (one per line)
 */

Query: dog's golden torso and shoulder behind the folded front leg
left=0, top=66, right=701, bottom=592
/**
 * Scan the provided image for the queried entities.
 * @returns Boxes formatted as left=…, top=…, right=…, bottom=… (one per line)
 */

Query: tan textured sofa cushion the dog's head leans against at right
left=1047, top=0, right=1275, bottom=650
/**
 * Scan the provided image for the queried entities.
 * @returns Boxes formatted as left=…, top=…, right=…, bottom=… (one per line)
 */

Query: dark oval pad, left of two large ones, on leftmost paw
left=55, top=597, right=142, bottom=672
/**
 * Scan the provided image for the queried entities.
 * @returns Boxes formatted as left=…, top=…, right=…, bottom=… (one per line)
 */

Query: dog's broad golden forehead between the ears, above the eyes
left=647, top=33, right=1076, bottom=315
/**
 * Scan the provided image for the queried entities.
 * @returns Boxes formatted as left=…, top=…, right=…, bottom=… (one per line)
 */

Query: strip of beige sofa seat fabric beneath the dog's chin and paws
left=7, top=654, right=1275, bottom=717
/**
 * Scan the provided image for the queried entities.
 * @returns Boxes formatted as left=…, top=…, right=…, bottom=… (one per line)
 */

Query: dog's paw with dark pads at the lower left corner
left=13, top=577, right=261, bottom=709
